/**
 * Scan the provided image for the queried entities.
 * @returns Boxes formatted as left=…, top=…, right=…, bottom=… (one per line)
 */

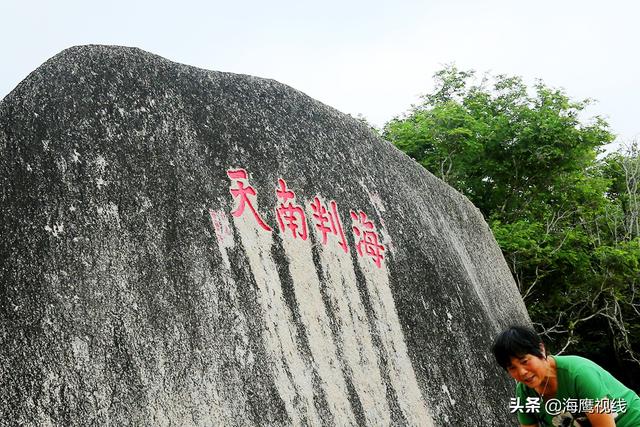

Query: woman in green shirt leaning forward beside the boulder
left=492, top=326, right=640, bottom=427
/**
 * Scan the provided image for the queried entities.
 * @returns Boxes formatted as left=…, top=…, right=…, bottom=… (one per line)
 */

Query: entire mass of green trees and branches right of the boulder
left=383, top=66, right=640, bottom=388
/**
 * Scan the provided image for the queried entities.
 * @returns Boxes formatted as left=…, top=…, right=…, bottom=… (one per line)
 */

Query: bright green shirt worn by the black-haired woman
left=512, top=356, right=640, bottom=427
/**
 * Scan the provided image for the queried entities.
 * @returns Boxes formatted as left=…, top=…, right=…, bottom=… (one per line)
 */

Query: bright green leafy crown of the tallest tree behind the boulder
left=383, top=67, right=613, bottom=219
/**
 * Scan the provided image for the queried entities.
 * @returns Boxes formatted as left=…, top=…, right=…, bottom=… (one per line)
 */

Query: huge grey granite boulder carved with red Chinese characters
left=0, top=46, right=528, bottom=426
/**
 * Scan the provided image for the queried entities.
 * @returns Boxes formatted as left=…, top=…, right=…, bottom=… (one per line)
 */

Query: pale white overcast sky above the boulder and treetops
left=0, top=0, right=640, bottom=147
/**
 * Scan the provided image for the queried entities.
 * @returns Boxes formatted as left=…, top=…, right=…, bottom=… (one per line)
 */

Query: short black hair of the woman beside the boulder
left=491, top=326, right=544, bottom=369
